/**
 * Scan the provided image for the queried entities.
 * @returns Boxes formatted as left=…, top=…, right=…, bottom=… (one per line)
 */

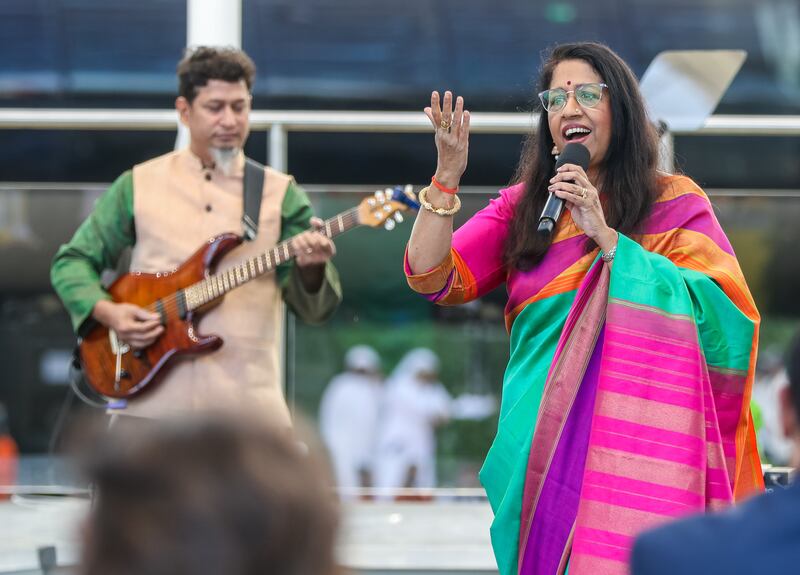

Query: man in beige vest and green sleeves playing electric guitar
left=51, top=47, right=341, bottom=425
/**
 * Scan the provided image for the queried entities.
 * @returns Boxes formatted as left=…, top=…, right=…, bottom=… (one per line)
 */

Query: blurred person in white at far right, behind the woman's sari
left=752, top=348, right=793, bottom=465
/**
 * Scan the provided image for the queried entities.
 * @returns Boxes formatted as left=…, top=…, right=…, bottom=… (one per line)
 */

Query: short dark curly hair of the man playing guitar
left=178, top=46, right=256, bottom=103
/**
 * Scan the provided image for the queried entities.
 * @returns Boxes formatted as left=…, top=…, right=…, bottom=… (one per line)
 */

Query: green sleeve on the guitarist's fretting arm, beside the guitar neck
left=276, top=180, right=342, bottom=323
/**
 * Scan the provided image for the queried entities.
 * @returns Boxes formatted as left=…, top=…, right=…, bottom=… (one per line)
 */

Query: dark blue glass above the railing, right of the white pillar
left=242, top=0, right=800, bottom=114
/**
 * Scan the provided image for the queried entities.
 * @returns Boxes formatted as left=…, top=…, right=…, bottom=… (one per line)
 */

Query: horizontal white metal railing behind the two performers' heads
left=0, top=108, right=800, bottom=170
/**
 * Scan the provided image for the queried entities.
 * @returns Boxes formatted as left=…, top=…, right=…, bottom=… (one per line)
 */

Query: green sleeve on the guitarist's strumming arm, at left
left=50, top=171, right=136, bottom=333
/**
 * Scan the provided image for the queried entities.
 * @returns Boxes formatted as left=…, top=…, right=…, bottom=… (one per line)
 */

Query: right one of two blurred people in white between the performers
left=375, top=347, right=452, bottom=489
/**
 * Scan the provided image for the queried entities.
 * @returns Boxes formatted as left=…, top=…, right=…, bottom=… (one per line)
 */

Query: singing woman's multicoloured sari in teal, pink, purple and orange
left=406, top=176, right=763, bottom=575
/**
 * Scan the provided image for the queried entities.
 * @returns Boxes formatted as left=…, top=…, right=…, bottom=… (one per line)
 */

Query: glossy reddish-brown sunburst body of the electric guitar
left=79, top=234, right=242, bottom=398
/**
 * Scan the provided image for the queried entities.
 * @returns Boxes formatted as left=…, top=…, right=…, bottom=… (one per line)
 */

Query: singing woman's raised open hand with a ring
left=425, top=90, right=469, bottom=188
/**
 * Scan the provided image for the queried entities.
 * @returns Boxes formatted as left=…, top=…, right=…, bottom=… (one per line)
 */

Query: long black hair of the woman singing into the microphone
left=504, top=42, right=658, bottom=270
